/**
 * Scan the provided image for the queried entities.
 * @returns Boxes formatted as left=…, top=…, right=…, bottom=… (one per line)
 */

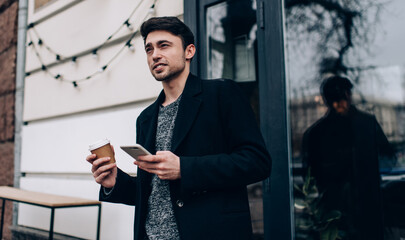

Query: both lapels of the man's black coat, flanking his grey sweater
left=140, top=74, right=202, bottom=153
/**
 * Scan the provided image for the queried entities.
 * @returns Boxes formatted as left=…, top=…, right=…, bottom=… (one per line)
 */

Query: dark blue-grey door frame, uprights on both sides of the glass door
left=184, top=0, right=294, bottom=240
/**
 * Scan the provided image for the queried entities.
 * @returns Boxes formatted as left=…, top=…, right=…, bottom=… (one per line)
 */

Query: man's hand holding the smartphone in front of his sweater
left=134, top=151, right=181, bottom=180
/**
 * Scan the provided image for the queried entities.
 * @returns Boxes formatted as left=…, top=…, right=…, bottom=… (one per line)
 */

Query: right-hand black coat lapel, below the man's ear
left=171, top=74, right=202, bottom=152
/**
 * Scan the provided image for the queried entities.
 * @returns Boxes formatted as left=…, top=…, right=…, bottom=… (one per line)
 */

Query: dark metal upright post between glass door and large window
left=257, top=0, right=294, bottom=240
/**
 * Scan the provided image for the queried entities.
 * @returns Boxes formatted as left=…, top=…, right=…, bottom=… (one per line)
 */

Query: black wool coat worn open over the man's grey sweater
left=100, top=74, right=271, bottom=240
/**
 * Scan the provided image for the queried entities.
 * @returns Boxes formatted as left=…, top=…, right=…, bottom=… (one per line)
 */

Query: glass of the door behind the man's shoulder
left=200, top=0, right=264, bottom=236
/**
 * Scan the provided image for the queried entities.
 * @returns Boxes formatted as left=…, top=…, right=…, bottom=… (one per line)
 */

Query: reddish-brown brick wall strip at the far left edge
left=0, top=0, right=18, bottom=239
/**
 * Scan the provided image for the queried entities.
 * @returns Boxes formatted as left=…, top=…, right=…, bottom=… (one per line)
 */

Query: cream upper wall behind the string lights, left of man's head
left=24, top=0, right=183, bottom=121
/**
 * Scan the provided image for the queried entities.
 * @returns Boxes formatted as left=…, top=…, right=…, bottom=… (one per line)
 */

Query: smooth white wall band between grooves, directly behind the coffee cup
left=21, top=101, right=151, bottom=174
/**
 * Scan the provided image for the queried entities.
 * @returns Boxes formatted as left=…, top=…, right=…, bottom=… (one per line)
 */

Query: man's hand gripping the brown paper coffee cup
left=86, top=148, right=117, bottom=188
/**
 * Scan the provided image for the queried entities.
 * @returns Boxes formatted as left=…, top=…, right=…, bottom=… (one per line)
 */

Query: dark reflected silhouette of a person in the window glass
left=302, top=76, right=394, bottom=240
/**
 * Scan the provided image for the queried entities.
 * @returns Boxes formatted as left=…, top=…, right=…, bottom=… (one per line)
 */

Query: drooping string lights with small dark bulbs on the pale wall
left=26, top=0, right=157, bottom=87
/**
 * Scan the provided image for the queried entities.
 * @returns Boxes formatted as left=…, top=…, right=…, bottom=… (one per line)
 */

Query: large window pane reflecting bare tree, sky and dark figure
left=284, top=0, right=405, bottom=240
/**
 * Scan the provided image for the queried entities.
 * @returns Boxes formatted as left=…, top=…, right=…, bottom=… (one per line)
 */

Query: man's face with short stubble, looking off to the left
left=145, top=30, right=187, bottom=81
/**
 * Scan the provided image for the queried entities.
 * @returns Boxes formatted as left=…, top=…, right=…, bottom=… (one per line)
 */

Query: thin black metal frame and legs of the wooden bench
left=0, top=197, right=101, bottom=240
